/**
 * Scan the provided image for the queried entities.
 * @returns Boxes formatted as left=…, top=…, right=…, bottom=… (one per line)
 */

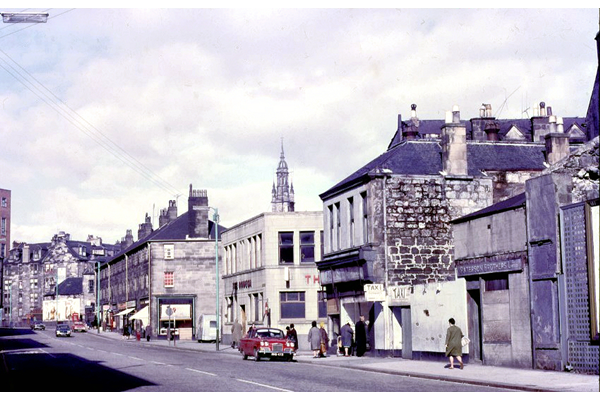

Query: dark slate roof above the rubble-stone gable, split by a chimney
left=320, top=140, right=545, bottom=199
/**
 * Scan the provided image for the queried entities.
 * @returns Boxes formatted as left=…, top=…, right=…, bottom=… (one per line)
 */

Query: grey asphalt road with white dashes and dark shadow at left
left=0, top=329, right=507, bottom=393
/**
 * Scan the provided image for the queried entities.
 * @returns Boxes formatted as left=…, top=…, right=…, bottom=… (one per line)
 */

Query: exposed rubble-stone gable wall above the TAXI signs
left=386, top=176, right=492, bottom=286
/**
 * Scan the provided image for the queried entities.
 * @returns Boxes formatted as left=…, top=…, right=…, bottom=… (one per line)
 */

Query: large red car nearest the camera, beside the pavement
left=239, top=328, right=295, bottom=361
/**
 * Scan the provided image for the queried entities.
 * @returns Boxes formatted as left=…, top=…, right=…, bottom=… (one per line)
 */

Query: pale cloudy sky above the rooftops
left=0, top=8, right=599, bottom=244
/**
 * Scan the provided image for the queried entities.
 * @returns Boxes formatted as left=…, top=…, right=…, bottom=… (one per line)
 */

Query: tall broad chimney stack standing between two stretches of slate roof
left=441, top=106, right=468, bottom=176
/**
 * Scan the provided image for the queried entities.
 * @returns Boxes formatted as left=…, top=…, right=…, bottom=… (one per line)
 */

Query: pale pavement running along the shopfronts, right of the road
left=87, top=331, right=599, bottom=392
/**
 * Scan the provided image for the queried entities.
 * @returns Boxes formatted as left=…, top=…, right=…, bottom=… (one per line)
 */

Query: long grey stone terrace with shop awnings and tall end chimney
left=99, top=185, right=225, bottom=339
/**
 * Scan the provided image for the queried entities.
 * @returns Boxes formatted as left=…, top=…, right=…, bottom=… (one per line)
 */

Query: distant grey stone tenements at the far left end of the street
left=2, top=232, right=118, bottom=325
